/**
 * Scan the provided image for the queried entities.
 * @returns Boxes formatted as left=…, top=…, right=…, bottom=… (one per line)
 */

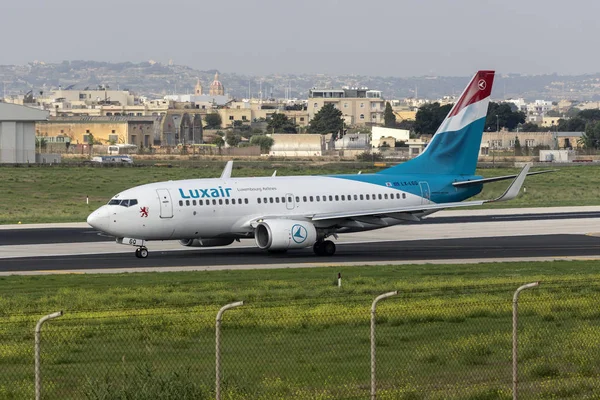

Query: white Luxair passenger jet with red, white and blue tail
left=87, top=71, right=550, bottom=258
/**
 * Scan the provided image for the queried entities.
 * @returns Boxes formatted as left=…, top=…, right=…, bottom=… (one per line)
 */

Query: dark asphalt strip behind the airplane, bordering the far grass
left=0, top=212, right=600, bottom=246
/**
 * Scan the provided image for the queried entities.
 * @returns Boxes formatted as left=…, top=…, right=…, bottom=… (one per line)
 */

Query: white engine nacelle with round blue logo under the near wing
left=254, top=219, right=317, bottom=250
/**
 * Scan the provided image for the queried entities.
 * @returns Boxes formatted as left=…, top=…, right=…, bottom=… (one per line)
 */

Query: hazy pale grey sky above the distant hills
left=0, top=0, right=600, bottom=77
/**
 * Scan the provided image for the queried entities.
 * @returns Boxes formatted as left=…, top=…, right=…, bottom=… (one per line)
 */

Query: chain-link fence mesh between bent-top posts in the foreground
left=0, top=282, right=600, bottom=400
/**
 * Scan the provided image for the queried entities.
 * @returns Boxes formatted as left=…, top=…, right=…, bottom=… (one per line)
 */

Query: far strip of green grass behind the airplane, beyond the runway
left=0, top=161, right=600, bottom=224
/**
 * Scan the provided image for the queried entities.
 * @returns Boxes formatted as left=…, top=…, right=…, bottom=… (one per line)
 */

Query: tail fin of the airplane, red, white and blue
left=379, top=71, right=495, bottom=175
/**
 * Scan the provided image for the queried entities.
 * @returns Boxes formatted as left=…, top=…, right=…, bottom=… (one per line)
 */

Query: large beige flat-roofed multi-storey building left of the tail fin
left=308, top=88, right=385, bottom=125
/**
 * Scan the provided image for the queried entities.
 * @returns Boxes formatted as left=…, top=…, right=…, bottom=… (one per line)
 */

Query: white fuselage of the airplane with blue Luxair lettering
left=88, top=176, right=430, bottom=240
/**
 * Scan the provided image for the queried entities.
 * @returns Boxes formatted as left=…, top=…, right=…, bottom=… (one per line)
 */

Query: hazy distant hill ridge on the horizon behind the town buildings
left=0, top=60, right=600, bottom=101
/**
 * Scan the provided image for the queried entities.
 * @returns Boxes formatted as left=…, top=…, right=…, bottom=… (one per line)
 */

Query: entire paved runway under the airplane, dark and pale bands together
left=0, top=208, right=600, bottom=275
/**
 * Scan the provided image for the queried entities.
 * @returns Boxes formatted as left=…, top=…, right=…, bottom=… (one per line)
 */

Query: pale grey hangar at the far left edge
left=0, top=103, right=49, bottom=164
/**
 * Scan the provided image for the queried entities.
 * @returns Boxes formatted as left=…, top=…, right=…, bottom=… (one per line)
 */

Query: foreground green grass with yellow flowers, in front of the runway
left=0, top=262, right=600, bottom=399
